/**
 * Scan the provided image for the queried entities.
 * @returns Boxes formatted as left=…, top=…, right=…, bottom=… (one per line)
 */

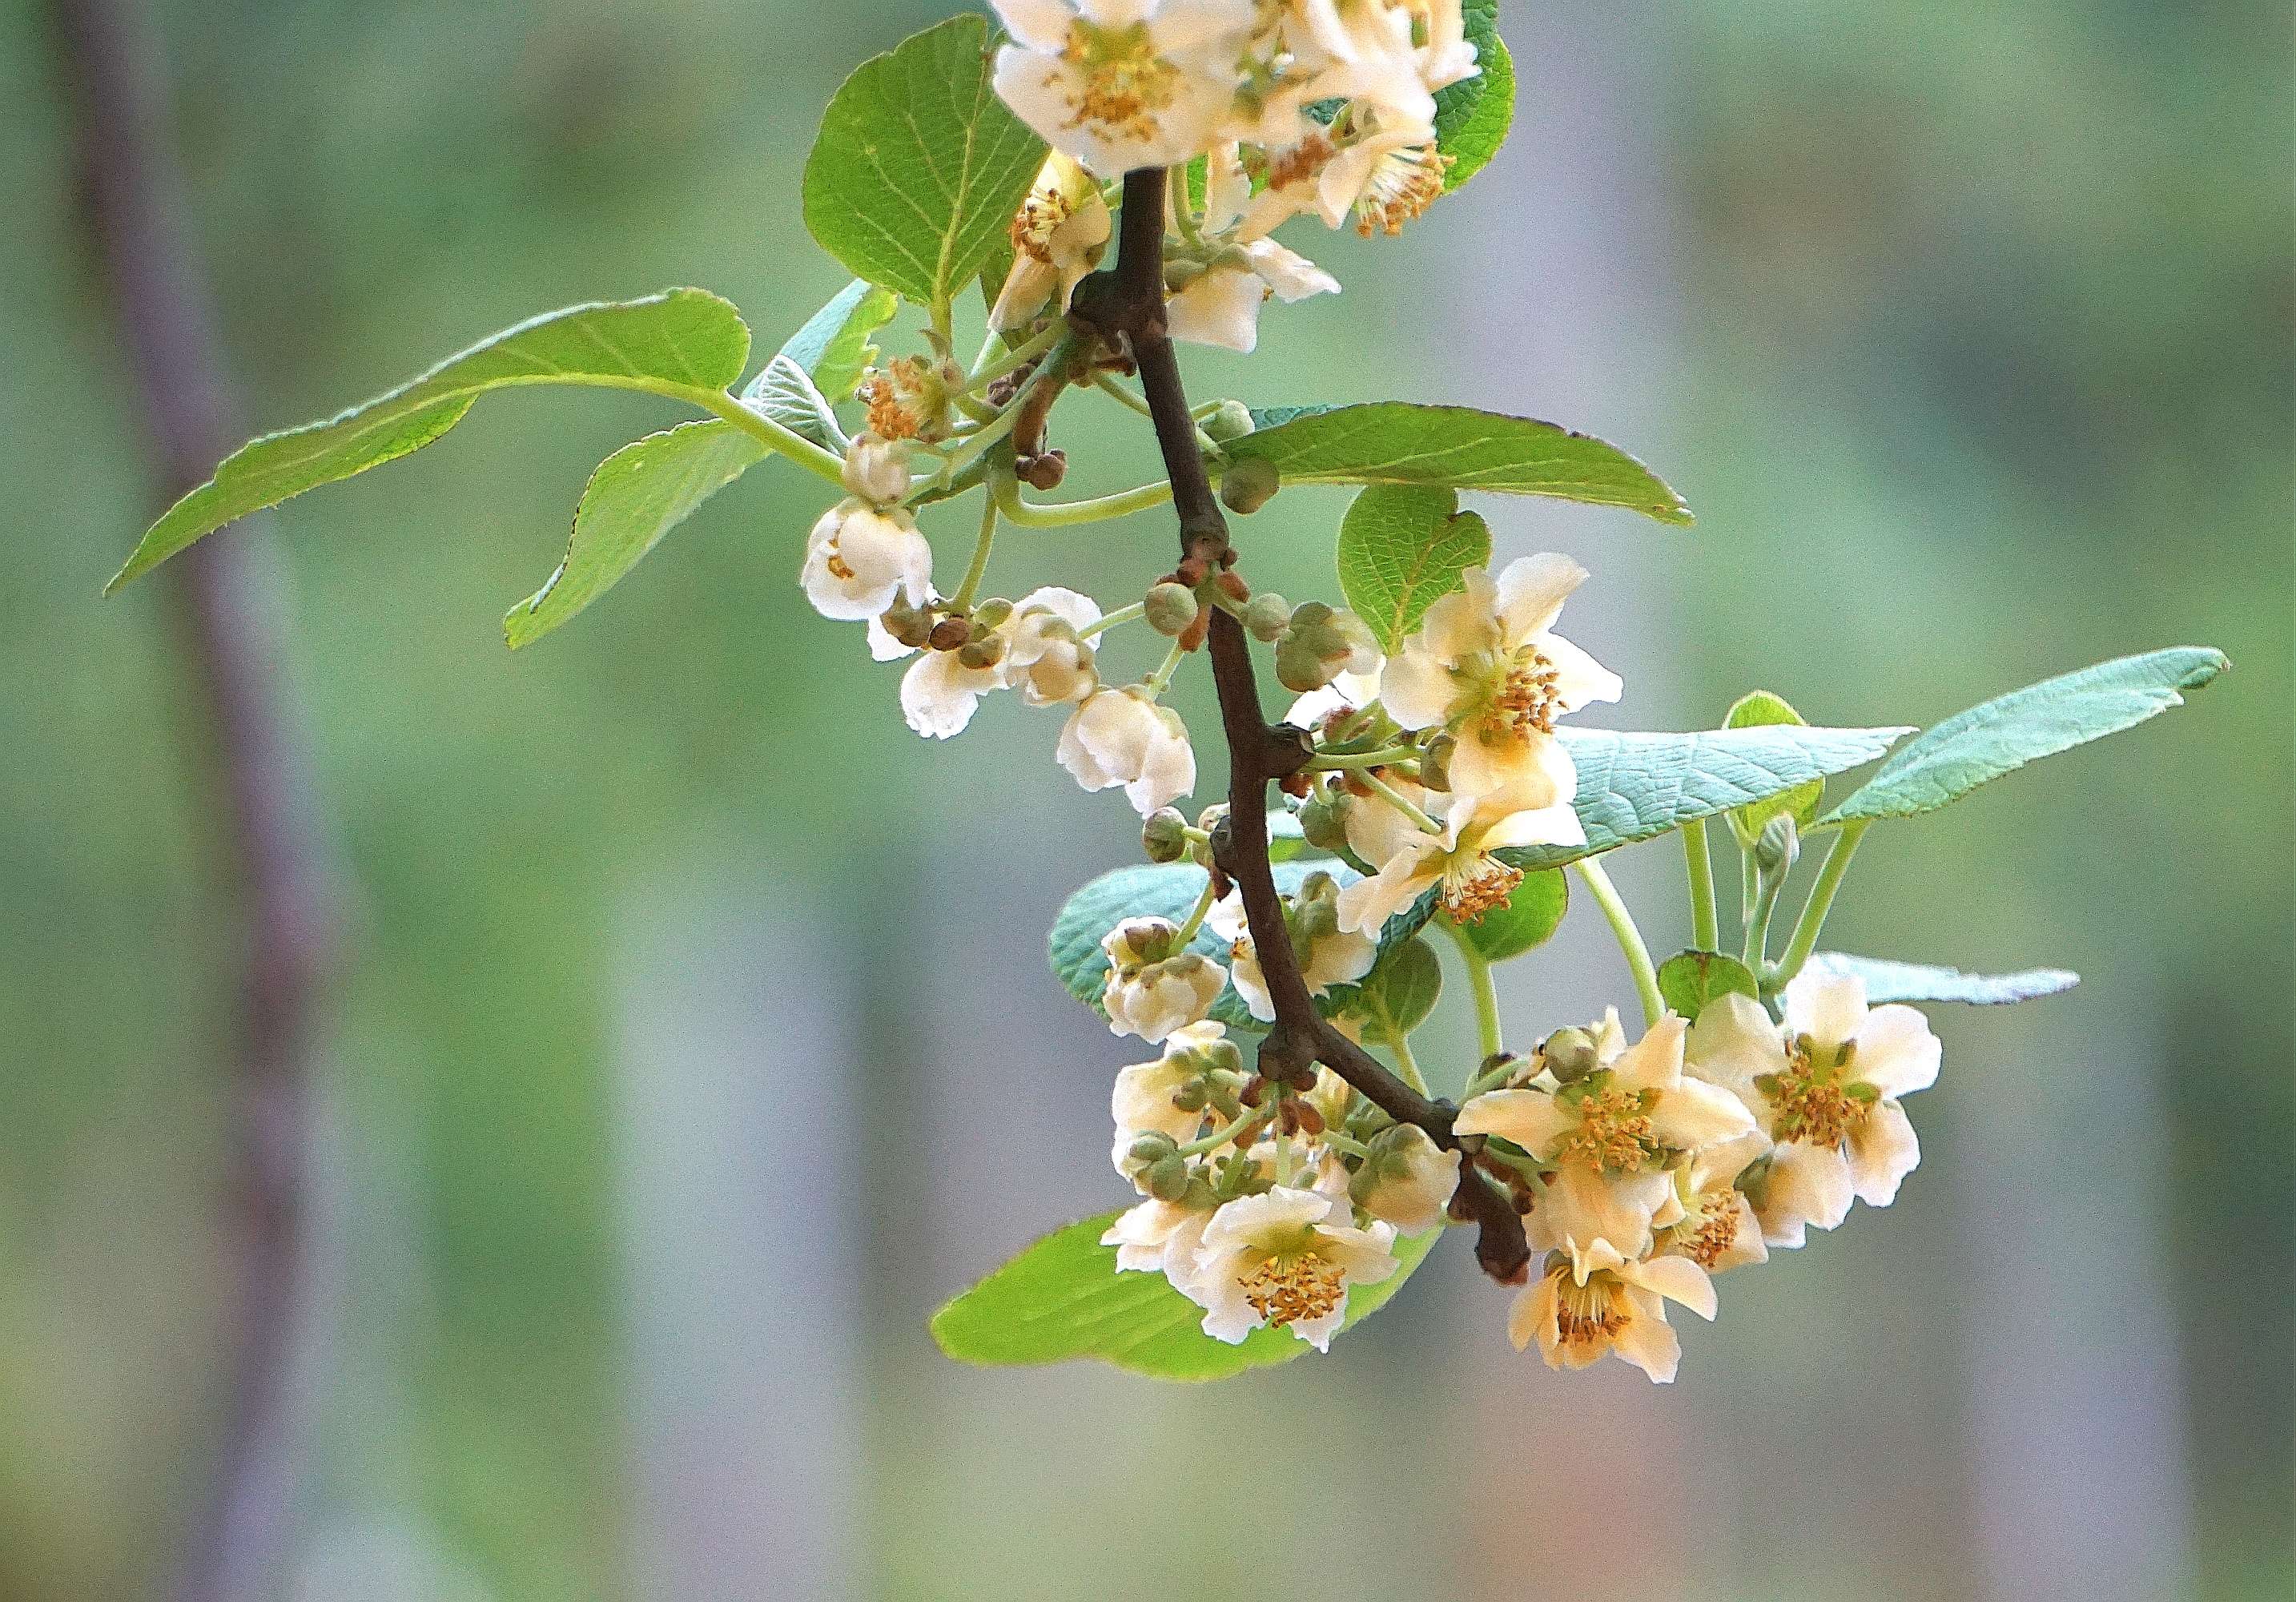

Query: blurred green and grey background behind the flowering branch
left=0, top=0, right=2296, bottom=1602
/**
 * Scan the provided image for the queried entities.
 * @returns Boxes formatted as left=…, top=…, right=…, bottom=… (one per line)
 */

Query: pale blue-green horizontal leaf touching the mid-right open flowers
left=1499, top=725, right=1912, bottom=867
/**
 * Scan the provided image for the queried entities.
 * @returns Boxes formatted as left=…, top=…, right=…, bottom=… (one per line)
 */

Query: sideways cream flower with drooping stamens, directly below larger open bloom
left=1338, top=780, right=1586, bottom=934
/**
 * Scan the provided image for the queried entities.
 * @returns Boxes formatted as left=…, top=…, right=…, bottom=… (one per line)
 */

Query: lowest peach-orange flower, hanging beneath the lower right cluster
left=1506, top=1242, right=1715, bottom=1384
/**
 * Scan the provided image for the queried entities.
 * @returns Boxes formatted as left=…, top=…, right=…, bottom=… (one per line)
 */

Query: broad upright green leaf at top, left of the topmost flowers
left=803, top=16, right=1044, bottom=308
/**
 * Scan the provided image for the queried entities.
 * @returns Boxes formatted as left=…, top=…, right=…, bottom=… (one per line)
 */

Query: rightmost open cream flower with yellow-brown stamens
left=1690, top=973, right=1942, bottom=1246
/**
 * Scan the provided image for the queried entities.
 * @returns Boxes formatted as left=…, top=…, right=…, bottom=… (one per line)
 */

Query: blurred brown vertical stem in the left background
left=48, top=0, right=337, bottom=1602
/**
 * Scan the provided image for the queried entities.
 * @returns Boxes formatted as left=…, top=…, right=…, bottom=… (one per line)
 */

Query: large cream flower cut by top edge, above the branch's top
left=992, top=0, right=1261, bottom=179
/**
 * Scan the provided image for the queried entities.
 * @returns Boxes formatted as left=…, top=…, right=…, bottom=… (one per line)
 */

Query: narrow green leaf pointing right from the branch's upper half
left=1226, top=401, right=1690, bottom=523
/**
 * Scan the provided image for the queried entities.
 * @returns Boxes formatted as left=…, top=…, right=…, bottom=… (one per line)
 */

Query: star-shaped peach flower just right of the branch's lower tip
left=1456, top=1012, right=1754, bottom=1258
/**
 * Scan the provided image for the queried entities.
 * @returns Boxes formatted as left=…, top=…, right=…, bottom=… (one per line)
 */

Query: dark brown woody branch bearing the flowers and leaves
left=1070, top=167, right=1529, bottom=1283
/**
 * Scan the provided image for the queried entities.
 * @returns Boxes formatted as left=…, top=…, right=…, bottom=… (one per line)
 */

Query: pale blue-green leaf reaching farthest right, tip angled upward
left=1823, top=645, right=2230, bottom=824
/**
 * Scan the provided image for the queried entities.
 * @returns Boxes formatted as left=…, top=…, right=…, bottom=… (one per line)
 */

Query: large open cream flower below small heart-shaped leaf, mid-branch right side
left=1380, top=553, right=1618, bottom=808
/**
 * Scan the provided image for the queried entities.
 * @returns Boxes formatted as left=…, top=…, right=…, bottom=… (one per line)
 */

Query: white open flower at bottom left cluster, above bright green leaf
left=1176, top=1185, right=1396, bottom=1352
